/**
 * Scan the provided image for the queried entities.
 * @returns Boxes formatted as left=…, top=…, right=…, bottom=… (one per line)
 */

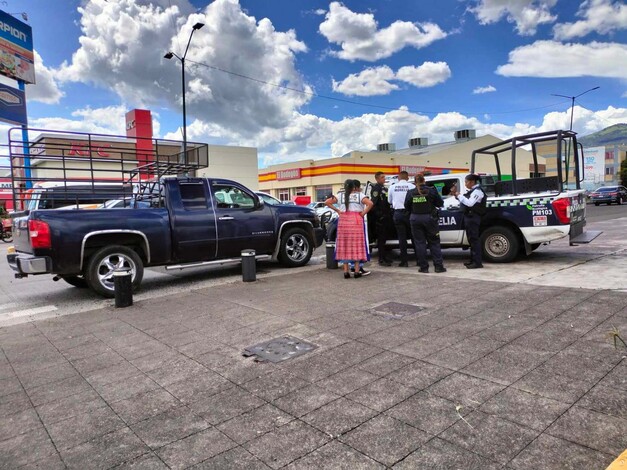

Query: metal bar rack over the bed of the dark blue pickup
left=0, top=128, right=209, bottom=211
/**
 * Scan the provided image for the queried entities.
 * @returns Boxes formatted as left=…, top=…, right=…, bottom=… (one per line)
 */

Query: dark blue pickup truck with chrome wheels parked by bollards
left=7, top=177, right=323, bottom=297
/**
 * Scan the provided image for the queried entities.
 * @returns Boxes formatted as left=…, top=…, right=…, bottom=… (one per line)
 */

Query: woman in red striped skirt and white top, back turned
left=325, top=179, right=373, bottom=279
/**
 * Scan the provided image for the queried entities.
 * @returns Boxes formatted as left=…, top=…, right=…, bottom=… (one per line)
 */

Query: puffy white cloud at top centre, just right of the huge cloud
left=319, top=2, right=447, bottom=62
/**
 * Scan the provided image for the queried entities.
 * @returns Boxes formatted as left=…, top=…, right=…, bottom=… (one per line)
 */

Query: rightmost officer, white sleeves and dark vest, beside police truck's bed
left=451, top=174, right=487, bottom=269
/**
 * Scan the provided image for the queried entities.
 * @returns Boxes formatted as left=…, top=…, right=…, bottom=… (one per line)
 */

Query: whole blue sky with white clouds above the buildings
left=7, top=0, right=627, bottom=166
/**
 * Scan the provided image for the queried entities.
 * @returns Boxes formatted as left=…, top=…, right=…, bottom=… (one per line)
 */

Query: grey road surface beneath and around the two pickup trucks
left=0, top=205, right=627, bottom=327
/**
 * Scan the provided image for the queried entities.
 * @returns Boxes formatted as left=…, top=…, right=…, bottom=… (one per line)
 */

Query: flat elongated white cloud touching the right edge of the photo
left=496, top=41, right=627, bottom=79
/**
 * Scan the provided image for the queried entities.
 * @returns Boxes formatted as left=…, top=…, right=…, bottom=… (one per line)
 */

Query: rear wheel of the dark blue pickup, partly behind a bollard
left=86, top=245, right=144, bottom=298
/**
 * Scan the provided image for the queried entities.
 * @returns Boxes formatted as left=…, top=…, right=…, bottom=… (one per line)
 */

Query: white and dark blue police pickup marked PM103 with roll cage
left=370, top=131, right=601, bottom=263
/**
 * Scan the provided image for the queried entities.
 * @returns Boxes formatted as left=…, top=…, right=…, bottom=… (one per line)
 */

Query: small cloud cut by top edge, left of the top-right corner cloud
left=469, top=0, right=557, bottom=36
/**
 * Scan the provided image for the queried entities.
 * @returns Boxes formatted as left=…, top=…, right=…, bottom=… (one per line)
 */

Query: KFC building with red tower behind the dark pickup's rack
left=0, top=110, right=259, bottom=210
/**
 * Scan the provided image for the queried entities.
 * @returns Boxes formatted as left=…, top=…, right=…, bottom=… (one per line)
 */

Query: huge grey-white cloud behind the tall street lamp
left=58, top=0, right=311, bottom=136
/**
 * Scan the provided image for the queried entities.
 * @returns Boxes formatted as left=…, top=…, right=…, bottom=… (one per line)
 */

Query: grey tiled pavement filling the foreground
left=0, top=269, right=627, bottom=470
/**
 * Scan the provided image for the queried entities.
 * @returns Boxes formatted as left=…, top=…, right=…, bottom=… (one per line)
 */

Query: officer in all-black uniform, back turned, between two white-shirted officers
left=405, top=173, right=446, bottom=273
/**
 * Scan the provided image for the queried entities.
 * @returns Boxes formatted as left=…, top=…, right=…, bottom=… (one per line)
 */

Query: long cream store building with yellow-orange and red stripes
left=259, top=129, right=542, bottom=201
